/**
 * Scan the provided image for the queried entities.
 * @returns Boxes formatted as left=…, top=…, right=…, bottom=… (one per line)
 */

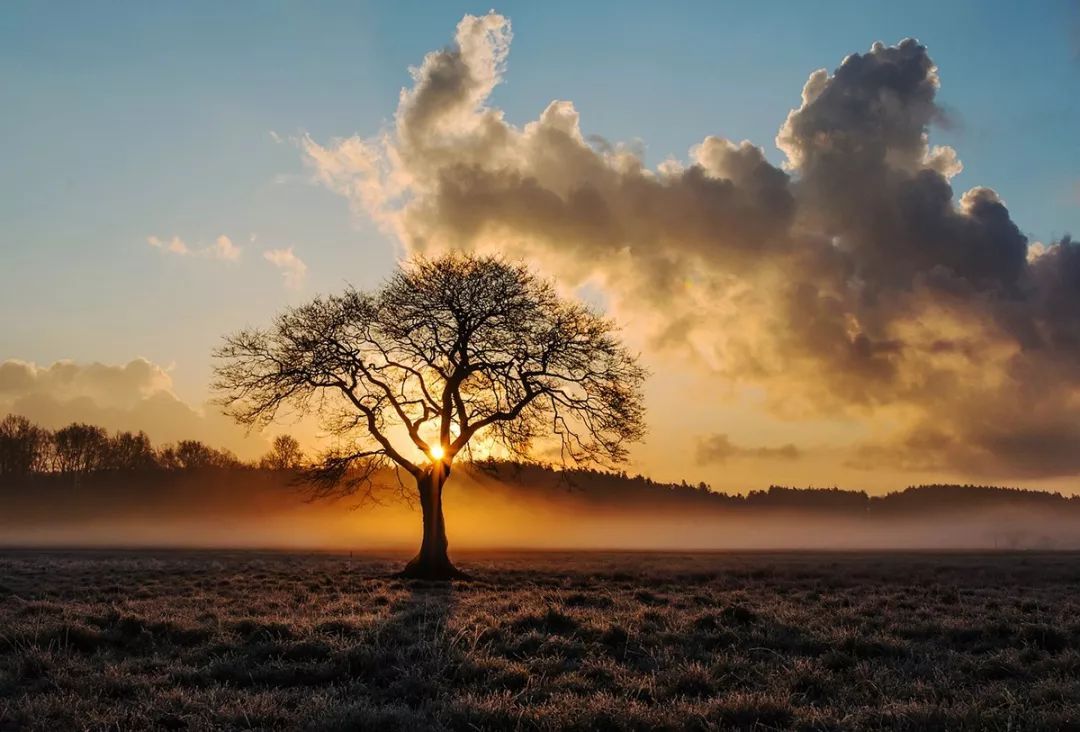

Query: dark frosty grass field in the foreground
left=0, top=551, right=1080, bottom=730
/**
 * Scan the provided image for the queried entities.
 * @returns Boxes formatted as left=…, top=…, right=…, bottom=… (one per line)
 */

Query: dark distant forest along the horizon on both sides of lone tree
left=0, top=415, right=1080, bottom=516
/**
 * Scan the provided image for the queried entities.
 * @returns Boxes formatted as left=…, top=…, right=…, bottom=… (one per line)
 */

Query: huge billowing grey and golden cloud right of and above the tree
left=301, top=13, right=1080, bottom=476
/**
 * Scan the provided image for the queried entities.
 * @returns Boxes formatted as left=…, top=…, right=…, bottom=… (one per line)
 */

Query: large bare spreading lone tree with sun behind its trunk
left=215, top=254, right=645, bottom=579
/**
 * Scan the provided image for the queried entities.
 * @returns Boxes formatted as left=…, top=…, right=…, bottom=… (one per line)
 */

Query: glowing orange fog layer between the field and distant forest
left=0, top=467, right=1080, bottom=552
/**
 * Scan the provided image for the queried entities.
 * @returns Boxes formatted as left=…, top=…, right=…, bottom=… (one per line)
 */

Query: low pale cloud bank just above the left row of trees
left=0, top=358, right=267, bottom=457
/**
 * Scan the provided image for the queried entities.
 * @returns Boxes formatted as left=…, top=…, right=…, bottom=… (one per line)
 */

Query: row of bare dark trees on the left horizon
left=0, top=415, right=307, bottom=478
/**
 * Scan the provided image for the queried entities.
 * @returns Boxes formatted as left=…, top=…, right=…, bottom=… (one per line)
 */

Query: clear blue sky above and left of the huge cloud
left=0, top=1, right=1080, bottom=488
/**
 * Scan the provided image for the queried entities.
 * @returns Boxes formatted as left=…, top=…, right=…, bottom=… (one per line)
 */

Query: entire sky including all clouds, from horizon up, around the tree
left=0, top=2, right=1080, bottom=492
